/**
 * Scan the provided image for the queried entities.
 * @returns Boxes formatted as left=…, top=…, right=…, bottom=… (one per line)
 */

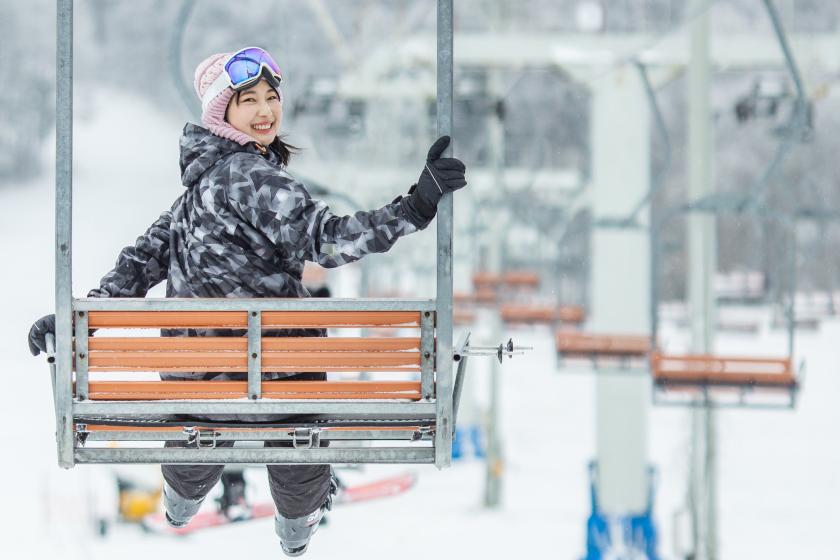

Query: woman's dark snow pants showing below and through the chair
left=161, top=373, right=330, bottom=519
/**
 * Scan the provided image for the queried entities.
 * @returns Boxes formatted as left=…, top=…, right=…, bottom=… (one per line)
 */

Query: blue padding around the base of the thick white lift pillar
left=585, top=462, right=659, bottom=560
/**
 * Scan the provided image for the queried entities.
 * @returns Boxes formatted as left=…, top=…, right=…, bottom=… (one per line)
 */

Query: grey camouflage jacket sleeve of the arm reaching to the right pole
left=227, top=161, right=419, bottom=268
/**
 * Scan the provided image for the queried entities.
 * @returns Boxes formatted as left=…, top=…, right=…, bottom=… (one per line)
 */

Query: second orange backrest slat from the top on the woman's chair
left=88, top=336, right=420, bottom=352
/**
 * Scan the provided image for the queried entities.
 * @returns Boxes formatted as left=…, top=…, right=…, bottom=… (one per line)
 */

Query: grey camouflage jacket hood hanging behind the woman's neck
left=180, top=123, right=280, bottom=187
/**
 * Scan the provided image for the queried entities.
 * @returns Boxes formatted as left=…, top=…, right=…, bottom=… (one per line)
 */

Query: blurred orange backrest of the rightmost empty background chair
left=651, top=354, right=796, bottom=387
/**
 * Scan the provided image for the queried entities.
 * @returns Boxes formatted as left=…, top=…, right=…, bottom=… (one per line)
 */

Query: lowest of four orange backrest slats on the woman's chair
left=88, top=380, right=420, bottom=401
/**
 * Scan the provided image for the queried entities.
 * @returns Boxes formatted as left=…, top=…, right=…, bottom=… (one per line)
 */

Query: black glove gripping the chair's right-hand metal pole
left=402, top=136, right=467, bottom=228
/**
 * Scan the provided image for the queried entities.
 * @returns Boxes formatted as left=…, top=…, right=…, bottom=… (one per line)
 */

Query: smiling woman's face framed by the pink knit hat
left=225, top=80, right=283, bottom=146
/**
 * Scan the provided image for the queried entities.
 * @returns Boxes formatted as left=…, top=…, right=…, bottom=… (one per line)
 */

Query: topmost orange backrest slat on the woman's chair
left=88, top=311, right=420, bottom=329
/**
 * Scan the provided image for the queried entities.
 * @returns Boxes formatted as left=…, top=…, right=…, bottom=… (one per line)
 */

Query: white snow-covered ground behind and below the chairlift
left=0, top=89, right=840, bottom=560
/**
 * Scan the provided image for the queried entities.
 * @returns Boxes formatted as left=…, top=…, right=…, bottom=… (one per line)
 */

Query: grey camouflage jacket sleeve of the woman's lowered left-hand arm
left=88, top=211, right=172, bottom=297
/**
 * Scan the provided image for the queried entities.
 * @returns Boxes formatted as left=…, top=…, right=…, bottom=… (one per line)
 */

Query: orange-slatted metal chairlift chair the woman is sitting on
left=48, top=0, right=515, bottom=468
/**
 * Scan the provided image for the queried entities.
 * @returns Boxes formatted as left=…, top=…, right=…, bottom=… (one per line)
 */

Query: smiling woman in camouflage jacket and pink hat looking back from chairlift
left=29, top=47, right=466, bottom=556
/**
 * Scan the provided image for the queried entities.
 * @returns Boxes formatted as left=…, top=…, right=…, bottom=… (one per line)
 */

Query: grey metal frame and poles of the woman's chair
left=49, top=0, right=462, bottom=468
